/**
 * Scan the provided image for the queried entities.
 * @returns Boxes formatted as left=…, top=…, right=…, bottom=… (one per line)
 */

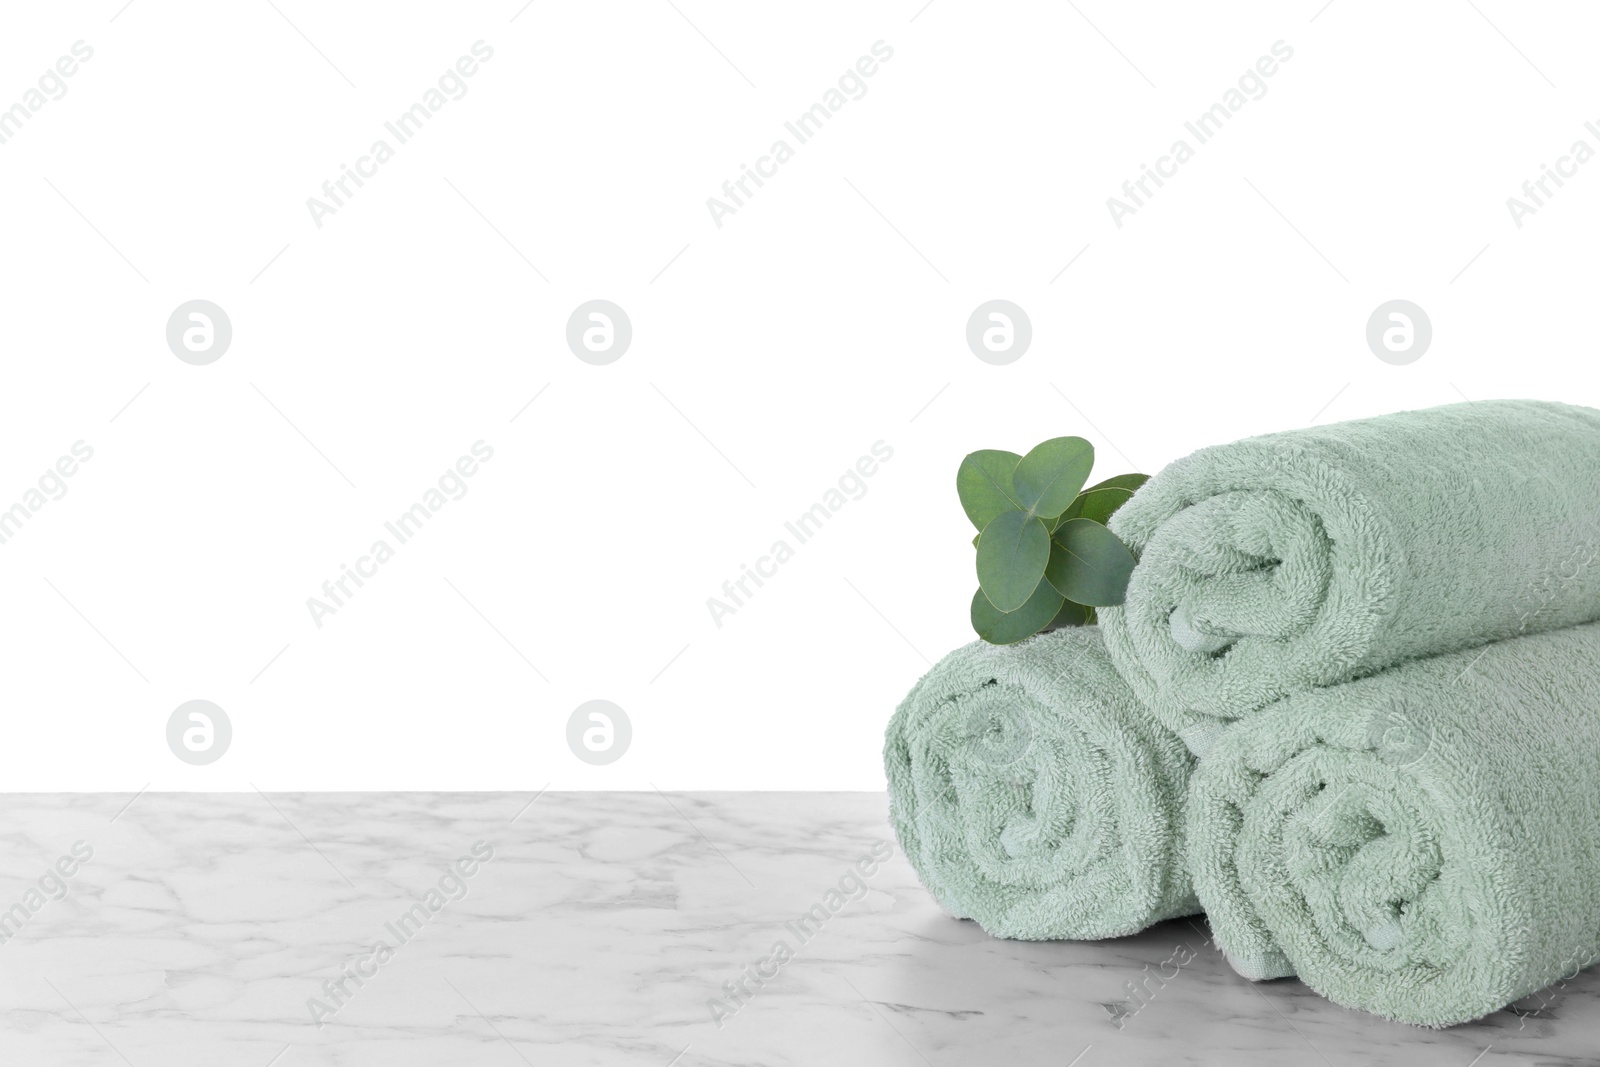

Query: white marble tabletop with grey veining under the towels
left=0, top=793, right=1600, bottom=1067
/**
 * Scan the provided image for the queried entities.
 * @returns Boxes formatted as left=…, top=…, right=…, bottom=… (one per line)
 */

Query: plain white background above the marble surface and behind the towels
left=0, top=0, right=1600, bottom=792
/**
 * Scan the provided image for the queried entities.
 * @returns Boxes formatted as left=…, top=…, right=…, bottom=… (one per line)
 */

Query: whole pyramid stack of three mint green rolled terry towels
left=885, top=400, right=1600, bottom=1025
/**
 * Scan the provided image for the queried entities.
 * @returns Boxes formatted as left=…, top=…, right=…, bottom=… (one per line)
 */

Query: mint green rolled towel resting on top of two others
left=1099, top=400, right=1600, bottom=753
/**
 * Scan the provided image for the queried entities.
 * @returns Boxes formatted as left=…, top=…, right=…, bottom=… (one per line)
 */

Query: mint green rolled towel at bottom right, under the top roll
left=1189, top=624, right=1600, bottom=1027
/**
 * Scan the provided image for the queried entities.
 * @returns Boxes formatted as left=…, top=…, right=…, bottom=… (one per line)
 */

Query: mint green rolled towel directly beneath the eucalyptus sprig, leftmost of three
left=883, top=627, right=1200, bottom=941
